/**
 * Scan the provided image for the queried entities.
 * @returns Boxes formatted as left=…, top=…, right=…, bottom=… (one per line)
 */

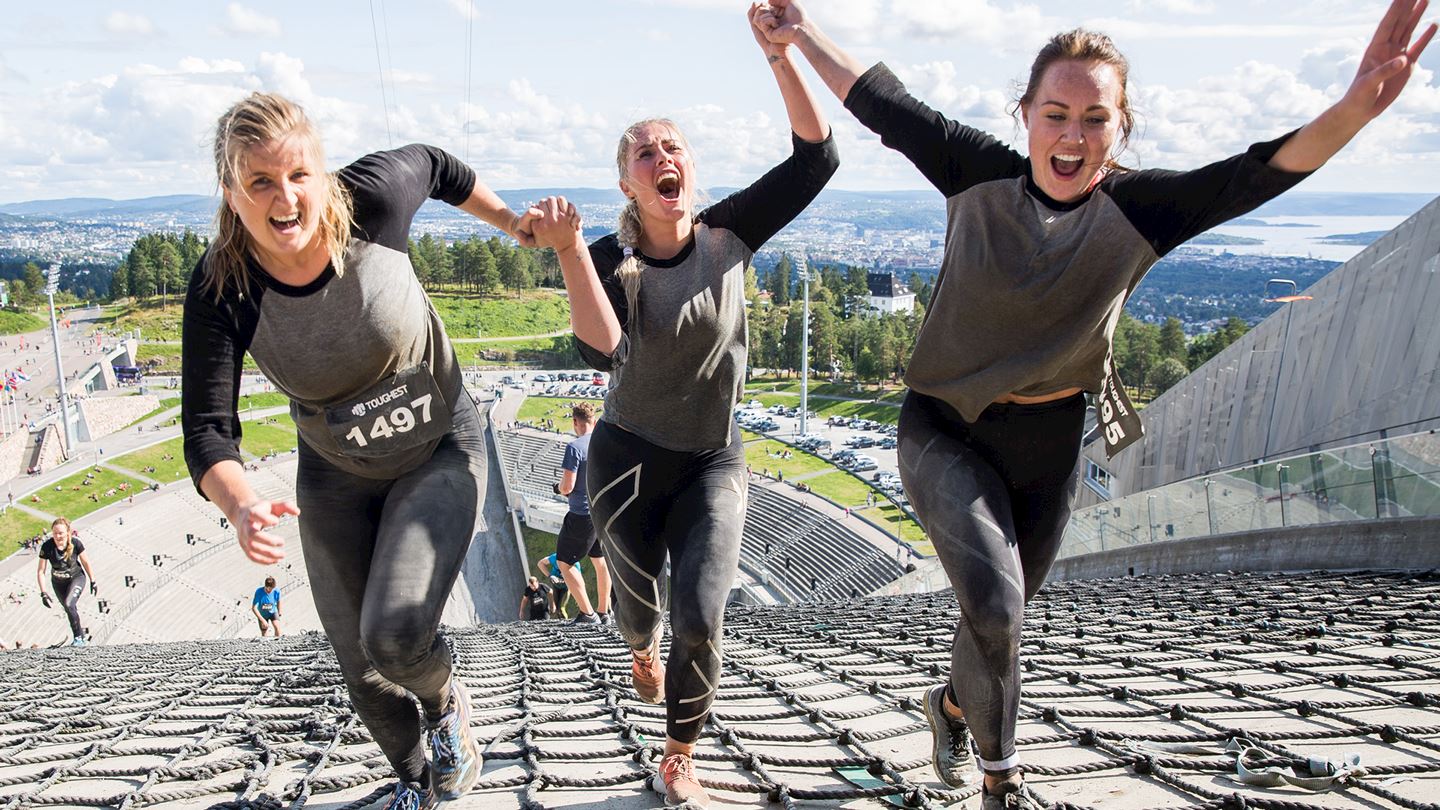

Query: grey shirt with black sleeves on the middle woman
left=576, top=135, right=840, bottom=451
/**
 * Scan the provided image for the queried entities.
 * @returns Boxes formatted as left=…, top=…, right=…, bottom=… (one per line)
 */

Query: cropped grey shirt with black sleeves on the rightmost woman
left=845, top=63, right=1306, bottom=421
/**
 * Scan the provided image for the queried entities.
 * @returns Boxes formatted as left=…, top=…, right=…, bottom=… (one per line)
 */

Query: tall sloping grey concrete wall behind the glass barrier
left=1077, top=200, right=1440, bottom=507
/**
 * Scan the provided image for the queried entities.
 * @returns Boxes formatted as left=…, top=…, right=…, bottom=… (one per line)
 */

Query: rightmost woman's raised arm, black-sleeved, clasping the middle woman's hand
left=756, top=0, right=1025, bottom=197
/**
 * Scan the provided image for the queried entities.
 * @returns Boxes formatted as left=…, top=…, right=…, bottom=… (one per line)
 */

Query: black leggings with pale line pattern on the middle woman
left=586, top=421, right=747, bottom=742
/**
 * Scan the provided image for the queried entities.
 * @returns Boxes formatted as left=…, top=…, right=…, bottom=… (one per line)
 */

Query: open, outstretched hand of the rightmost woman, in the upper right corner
left=1341, top=0, right=1436, bottom=121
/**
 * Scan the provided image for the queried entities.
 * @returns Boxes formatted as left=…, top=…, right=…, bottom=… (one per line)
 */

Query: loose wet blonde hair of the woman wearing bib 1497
left=204, top=92, right=354, bottom=298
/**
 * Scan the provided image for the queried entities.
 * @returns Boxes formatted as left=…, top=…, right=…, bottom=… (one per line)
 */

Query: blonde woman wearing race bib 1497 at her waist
left=181, top=94, right=541, bottom=810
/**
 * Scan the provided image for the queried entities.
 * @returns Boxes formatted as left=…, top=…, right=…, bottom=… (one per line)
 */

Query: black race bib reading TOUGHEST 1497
left=325, top=363, right=451, bottom=458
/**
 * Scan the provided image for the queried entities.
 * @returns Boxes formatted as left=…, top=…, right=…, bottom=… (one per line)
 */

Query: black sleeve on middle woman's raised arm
left=700, top=133, right=840, bottom=252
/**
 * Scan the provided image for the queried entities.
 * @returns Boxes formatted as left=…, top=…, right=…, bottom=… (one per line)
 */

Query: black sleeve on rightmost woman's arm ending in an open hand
left=1103, top=133, right=1310, bottom=257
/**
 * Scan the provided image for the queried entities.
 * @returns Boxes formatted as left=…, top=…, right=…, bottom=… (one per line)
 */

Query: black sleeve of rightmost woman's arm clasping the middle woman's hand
left=845, top=62, right=1030, bottom=197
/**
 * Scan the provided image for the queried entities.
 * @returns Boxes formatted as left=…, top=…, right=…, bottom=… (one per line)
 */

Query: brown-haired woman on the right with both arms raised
left=757, top=0, right=1434, bottom=810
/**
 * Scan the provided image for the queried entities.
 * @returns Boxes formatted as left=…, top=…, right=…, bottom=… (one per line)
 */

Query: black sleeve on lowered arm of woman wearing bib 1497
left=180, top=258, right=259, bottom=497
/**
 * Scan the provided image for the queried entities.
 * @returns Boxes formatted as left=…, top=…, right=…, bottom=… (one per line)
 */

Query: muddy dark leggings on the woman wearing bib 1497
left=295, top=393, right=487, bottom=784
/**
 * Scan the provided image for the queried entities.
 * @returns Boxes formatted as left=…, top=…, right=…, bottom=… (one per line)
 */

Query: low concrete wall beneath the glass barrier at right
left=1050, top=517, right=1440, bottom=579
